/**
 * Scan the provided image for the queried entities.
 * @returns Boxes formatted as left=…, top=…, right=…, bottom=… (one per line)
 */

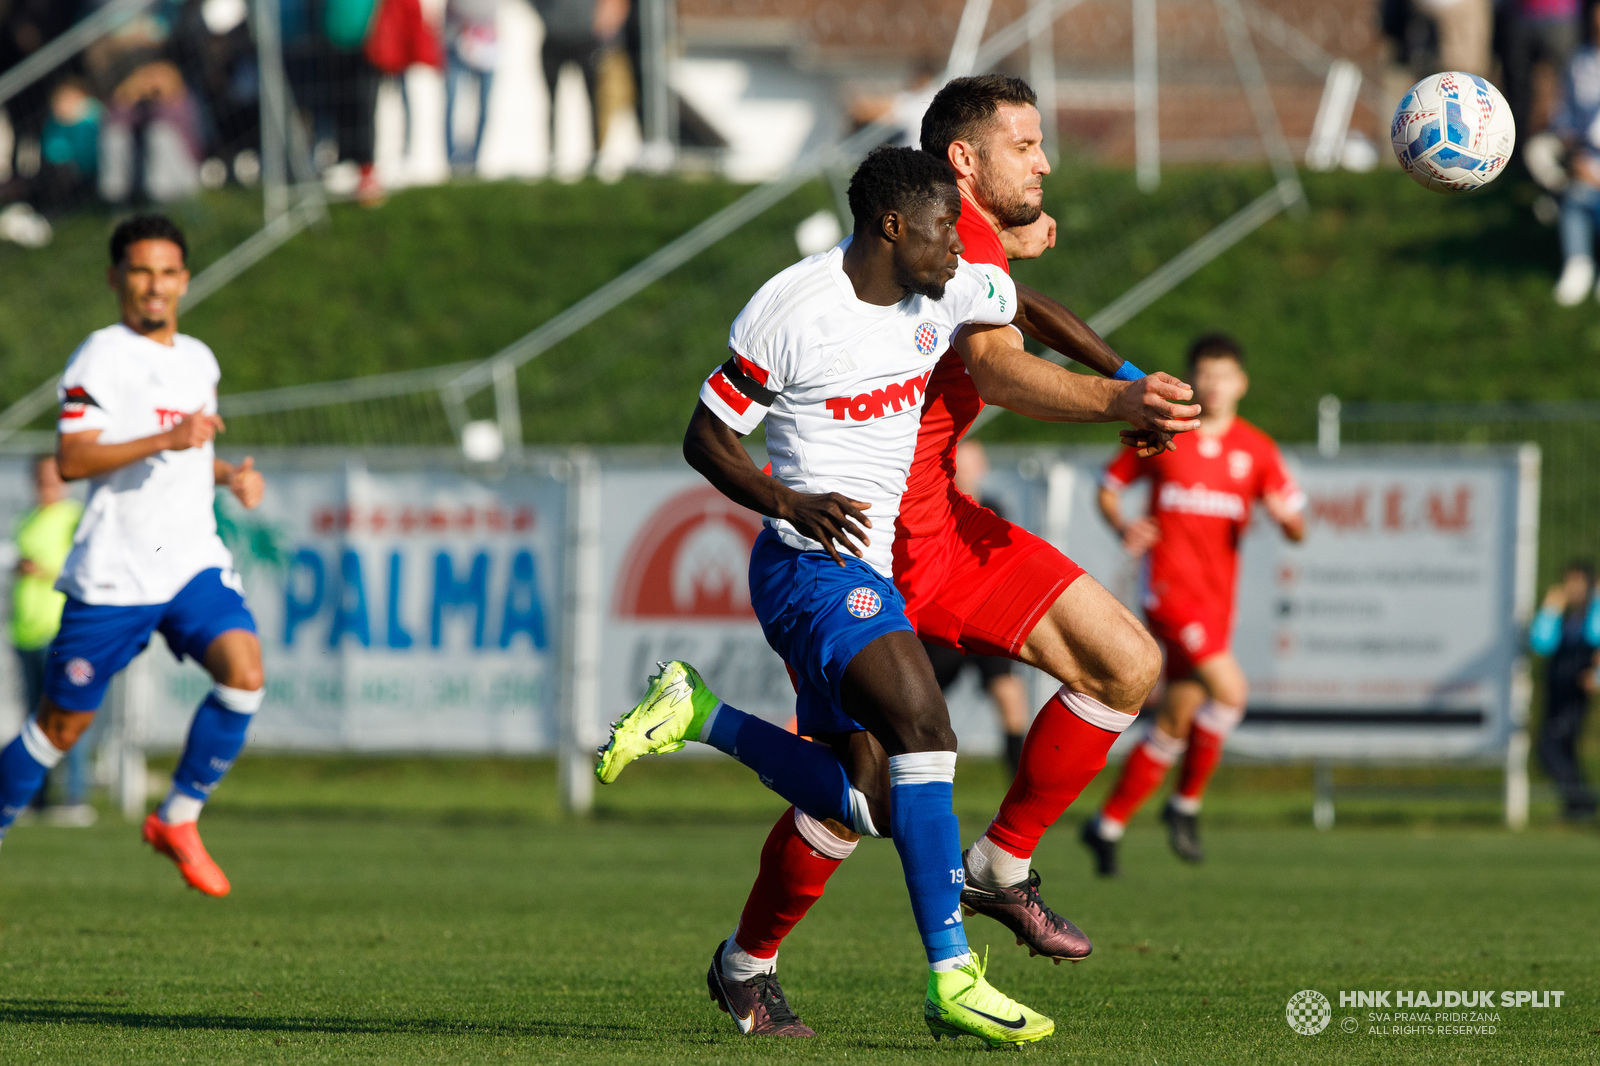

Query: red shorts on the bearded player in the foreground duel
left=894, top=496, right=1083, bottom=659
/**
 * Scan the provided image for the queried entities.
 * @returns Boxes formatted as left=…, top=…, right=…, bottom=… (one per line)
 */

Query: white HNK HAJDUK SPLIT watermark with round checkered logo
left=1285, top=988, right=1566, bottom=1037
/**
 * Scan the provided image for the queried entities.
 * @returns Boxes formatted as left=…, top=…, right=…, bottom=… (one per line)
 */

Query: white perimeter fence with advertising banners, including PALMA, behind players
left=0, top=445, right=1539, bottom=824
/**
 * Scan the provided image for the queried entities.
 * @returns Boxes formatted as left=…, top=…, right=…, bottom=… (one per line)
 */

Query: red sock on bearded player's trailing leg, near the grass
left=734, top=807, right=856, bottom=959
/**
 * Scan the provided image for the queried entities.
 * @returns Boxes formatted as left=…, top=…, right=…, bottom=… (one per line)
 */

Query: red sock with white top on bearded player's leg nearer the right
left=986, top=685, right=1134, bottom=858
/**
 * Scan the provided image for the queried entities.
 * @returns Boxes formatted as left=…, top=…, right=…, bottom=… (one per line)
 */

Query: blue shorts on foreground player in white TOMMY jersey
left=750, top=528, right=915, bottom=736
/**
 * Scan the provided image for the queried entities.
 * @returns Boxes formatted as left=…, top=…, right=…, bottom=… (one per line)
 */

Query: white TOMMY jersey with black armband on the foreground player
left=701, top=240, right=1016, bottom=578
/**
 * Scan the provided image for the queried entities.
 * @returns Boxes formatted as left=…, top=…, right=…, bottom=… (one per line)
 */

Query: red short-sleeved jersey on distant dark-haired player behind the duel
left=1104, top=418, right=1306, bottom=616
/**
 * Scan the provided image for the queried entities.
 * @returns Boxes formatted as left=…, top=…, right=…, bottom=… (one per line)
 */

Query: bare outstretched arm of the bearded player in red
left=955, top=316, right=1200, bottom=451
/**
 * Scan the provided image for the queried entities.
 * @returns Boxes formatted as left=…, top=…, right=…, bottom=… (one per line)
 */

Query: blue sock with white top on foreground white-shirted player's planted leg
left=890, top=751, right=970, bottom=970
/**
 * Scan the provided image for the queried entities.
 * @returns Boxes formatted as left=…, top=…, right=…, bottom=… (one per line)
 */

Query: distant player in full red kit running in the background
left=1082, top=333, right=1306, bottom=876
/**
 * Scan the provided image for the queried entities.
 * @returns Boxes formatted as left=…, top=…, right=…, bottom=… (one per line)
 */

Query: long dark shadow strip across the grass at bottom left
left=0, top=999, right=659, bottom=1042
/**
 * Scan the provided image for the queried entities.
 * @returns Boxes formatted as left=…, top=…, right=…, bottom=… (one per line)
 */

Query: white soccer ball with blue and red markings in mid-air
left=1389, top=70, right=1517, bottom=192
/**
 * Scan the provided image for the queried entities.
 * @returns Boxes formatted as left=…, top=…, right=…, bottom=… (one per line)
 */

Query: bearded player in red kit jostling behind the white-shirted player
left=700, top=75, right=1194, bottom=1036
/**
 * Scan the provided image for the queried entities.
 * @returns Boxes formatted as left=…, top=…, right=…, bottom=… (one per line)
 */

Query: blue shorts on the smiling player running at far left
left=45, top=568, right=256, bottom=711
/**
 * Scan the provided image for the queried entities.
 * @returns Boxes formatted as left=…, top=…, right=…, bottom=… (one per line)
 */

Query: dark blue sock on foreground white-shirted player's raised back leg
left=699, top=704, right=851, bottom=826
